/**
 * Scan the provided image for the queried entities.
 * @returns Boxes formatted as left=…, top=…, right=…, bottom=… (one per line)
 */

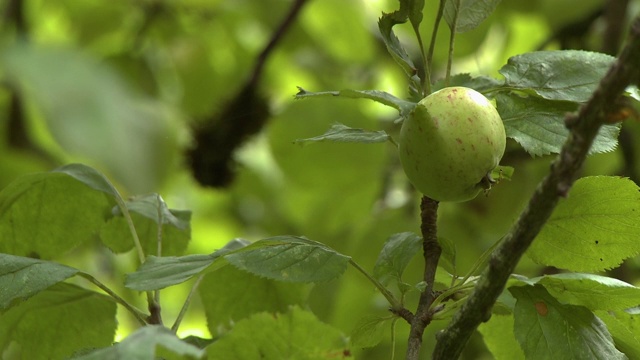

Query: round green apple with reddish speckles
left=399, top=87, right=506, bottom=202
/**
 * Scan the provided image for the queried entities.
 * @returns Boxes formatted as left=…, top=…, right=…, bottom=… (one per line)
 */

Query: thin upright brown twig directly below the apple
left=407, top=196, right=442, bottom=360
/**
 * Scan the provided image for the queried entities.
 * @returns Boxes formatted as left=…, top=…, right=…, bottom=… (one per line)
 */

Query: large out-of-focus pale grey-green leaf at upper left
left=0, top=43, right=179, bottom=193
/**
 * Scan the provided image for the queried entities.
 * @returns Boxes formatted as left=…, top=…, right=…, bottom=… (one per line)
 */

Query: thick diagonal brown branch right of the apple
left=433, top=18, right=640, bottom=360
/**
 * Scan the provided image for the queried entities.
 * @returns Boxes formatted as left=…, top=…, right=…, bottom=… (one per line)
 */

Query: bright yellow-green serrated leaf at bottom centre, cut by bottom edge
left=207, top=307, right=352, bottom=360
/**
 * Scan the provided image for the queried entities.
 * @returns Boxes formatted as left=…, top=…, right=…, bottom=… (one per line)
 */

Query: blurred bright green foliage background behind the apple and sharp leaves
left=0, top=0, right=640, bottom=359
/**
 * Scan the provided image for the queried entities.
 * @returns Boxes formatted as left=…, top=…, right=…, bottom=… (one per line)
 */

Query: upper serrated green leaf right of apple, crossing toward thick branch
left=500, top=50, right=615, bottom=102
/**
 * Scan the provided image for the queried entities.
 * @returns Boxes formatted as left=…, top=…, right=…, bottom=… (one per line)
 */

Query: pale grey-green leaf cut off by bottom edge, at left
left=74, top=325, right=205, bottom=360
